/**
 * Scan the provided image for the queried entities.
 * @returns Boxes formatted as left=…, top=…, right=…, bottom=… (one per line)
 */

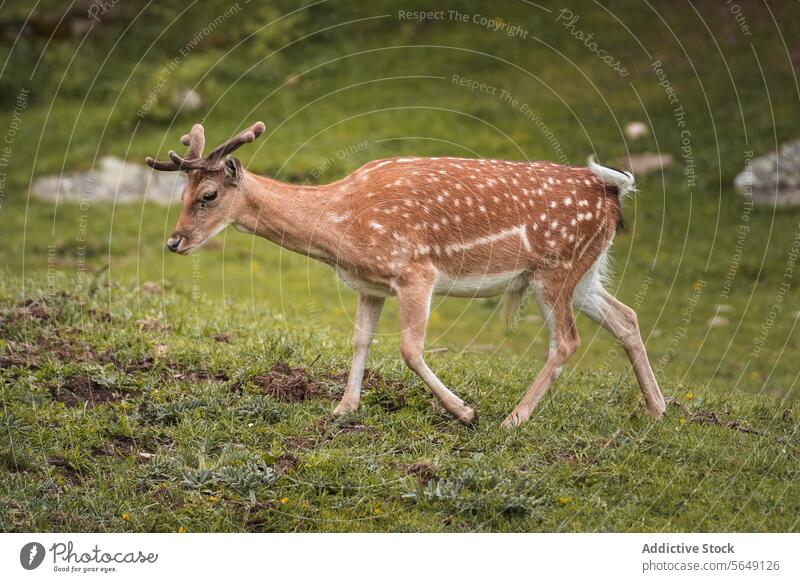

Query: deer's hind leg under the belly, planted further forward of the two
left=502, top=283, right=580, bottom=427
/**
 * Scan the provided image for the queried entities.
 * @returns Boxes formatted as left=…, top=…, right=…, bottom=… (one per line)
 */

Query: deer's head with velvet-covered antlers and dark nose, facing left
left=145, top=121, right=265, bottom=254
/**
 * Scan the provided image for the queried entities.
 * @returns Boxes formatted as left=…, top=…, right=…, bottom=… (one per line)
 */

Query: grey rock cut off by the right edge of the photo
left=733, top=139, right=800, bottom=206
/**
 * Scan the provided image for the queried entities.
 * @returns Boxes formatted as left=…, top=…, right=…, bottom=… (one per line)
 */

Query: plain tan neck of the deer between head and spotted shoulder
left=234, top=172, right=340, bottom=260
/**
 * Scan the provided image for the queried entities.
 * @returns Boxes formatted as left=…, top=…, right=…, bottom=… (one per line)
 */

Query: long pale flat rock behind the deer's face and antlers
left=32, top=156, right=186, bottom=205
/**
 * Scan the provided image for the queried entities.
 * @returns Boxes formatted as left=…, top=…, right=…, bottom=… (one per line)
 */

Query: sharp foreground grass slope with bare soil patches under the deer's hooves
left=0, top=285, right=800, bottom=531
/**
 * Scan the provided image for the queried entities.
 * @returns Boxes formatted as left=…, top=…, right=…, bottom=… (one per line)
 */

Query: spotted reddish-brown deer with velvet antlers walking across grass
left=145, top=121, right=666, bottom=427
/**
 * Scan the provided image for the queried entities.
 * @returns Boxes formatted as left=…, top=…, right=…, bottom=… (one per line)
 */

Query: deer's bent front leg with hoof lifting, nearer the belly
left=397, top=277, right=478, bottom=424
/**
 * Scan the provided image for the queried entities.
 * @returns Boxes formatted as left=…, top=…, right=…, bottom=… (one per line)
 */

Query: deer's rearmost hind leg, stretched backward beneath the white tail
left=573, top=271, right=667, bottom=417
